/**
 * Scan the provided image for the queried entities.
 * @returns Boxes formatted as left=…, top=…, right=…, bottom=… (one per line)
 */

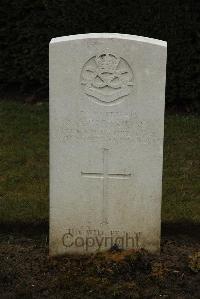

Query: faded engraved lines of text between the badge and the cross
left=59, top=111, right=160, bottom=145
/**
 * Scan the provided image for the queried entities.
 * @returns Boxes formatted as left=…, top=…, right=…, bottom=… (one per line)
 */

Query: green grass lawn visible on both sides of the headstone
left=0, top=101, right=200, bottom=224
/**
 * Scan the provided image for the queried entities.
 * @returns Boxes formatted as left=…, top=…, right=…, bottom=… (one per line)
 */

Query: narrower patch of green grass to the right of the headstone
left=162, top=115, right=200, bottom=223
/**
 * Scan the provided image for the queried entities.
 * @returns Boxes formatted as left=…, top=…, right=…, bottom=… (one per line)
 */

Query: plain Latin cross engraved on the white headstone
left=81, top=148, right=131, bottom=224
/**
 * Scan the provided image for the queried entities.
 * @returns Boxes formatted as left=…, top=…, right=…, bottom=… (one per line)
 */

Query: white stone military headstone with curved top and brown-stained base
left=50, top=33, right=167, bottom=255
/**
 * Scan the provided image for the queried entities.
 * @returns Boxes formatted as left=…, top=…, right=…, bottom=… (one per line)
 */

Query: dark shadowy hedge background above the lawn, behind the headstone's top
left=0, top=0, right=200, bottom=112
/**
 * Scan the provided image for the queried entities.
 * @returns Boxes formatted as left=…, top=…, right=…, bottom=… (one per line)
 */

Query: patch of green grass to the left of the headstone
left=0, top=101, right=49, bottom=223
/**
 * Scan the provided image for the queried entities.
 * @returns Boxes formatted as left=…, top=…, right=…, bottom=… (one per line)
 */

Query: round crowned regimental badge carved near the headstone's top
left=81, top=51, right=134, bottom=105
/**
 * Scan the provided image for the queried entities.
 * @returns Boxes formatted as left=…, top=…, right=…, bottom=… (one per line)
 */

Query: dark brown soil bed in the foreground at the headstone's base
left=0, top=227, right=200, bottom=299
